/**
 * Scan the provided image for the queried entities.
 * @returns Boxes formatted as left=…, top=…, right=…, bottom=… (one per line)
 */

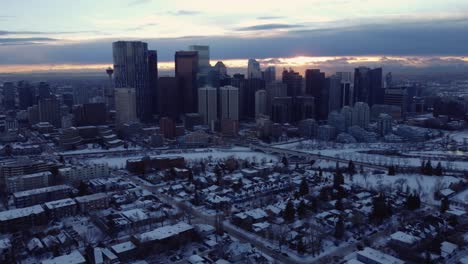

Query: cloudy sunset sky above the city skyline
left=0, top=0, right=468, bottom=73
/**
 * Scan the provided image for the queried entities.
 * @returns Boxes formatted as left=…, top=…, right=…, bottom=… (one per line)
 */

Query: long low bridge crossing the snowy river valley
left=250, top=144, right=387, bottom=171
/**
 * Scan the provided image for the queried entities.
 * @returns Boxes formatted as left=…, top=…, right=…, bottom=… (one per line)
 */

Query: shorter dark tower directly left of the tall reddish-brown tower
left=158, top=77, right=179, bottom=120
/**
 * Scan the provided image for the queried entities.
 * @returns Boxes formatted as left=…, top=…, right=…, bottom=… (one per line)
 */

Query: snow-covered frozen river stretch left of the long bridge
left=88, top=147, right=278, bottom=168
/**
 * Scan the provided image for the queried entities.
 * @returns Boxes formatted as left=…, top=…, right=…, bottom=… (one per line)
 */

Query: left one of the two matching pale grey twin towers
left=198, top=87, right=218, bottom=127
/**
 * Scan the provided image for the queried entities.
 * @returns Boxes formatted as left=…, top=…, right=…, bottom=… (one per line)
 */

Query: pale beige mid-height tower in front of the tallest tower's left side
left=114, top=88, right=138, bottom=125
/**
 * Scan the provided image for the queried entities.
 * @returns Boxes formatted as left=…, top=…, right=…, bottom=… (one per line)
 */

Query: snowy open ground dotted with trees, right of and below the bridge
left=345, top=174, right=460, bottom=205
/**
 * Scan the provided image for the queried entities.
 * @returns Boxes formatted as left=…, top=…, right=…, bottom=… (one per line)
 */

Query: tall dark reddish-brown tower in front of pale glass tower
left=175, top=51, right=198, bottom=113
